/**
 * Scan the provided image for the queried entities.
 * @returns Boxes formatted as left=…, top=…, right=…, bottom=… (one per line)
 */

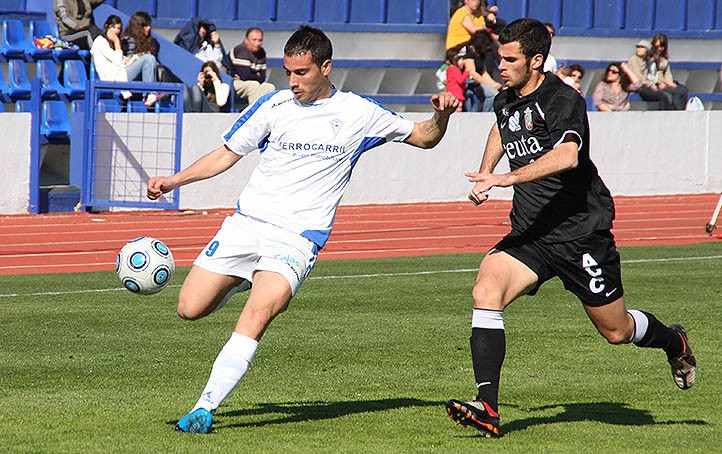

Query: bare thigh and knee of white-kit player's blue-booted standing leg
left=236, top=270, right=293, bottom=340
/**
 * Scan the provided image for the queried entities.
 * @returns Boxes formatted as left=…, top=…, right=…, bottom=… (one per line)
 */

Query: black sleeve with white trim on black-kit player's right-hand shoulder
left=544, top=88, right=588, bottom=148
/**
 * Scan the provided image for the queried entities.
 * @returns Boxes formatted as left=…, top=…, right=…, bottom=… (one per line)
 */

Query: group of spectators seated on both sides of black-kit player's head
left=437, top=0, right=688, bottom=112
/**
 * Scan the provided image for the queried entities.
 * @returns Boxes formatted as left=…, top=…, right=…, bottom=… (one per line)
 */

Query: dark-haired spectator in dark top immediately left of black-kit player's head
left=462, top=30, right=503, bottom=112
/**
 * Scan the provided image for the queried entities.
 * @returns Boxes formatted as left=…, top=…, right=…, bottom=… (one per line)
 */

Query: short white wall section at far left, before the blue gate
left=0, top=113, right=30, bottom=214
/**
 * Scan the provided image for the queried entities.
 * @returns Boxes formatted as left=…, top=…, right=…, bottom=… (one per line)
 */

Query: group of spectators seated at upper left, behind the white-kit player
left=54, top=0, right=276, bottom=112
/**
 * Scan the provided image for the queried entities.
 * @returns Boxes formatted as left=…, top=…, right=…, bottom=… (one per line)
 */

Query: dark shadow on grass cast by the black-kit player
left=501, top=402, right=708, bottom=434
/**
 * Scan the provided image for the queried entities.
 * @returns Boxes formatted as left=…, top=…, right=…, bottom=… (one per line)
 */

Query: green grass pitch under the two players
left=0, top=243, right=722, bottom=453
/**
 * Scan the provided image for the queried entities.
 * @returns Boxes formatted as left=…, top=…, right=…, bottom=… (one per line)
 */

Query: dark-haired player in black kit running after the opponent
left=446, top=19, right=696, bottom=437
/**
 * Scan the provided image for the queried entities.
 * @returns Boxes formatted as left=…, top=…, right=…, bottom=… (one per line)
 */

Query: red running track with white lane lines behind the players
left=0, top=194, right=719, bottom=275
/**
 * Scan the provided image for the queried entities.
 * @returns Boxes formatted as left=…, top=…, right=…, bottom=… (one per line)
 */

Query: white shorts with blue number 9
left=193, top=213, right=318, bottom=295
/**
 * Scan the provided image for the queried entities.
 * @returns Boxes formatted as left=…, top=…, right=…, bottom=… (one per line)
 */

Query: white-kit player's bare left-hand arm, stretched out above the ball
left=146, top=145, right=241, bottom=200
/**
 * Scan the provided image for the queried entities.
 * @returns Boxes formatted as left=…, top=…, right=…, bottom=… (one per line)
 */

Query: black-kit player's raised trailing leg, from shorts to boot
left=585, top=298, right=697, bottom=389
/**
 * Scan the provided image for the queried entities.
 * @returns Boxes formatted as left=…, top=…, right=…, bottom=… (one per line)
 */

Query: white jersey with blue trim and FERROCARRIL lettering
left=223, top=90, right=414, bottom=248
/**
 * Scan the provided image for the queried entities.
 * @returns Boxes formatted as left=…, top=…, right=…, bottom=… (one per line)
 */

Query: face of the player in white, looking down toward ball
left=283, top=52, right=333, bottom=104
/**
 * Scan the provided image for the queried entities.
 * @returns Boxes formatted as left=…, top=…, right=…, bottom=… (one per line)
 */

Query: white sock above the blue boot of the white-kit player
left=191, top=332, right=258, bottom=411
